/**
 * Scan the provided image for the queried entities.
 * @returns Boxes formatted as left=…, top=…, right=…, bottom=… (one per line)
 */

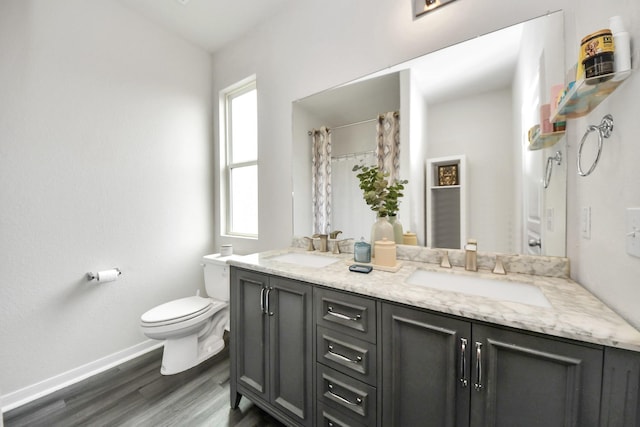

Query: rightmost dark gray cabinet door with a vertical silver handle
left=471, top=324, right=603, bottom=427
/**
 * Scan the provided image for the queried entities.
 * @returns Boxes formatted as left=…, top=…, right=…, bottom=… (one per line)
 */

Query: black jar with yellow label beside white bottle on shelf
left=578, top=29, right=615, bottom=84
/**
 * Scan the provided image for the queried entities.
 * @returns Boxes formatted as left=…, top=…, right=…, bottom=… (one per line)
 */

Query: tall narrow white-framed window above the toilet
left=223, top=79, right=258, bottom=237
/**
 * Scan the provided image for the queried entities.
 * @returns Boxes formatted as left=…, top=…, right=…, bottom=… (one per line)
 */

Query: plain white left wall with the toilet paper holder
left=0, top=0, right=214, bottom=405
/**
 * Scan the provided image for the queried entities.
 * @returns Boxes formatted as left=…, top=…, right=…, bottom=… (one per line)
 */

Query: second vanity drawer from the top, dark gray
left=316, top=326, right=376, bottom=385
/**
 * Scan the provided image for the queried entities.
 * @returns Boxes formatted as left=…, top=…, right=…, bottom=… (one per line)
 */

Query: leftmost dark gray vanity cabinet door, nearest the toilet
left=231, top=269, right=269, bottom=405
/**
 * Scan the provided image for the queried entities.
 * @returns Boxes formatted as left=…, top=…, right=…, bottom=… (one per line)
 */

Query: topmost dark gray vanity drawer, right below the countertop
left=313, top=288, right=376, bottom=343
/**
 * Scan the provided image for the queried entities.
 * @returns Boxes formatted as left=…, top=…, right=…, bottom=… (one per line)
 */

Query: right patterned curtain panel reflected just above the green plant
left=376, top=111, right=400, bottom=182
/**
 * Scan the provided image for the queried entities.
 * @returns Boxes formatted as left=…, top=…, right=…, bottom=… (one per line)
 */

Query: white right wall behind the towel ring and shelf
left=566, top=0, right=640, bottom=328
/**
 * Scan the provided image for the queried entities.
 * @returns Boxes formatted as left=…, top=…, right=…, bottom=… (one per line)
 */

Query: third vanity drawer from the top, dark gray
left=316, top=363, right=377, bottom=426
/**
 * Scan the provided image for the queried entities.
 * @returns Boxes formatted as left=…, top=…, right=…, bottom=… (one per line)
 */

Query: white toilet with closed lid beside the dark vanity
left=140, top=254, right=237, bottom=375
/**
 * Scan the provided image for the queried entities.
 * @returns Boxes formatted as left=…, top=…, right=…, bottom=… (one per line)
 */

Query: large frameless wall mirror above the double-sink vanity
left=293, top=12, right=566, bottom=256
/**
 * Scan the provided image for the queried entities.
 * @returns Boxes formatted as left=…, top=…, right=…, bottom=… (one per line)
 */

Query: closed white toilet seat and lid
left=140, top=296, right=226, bottom=327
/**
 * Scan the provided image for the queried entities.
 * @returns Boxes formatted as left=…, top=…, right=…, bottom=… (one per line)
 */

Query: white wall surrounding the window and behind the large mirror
left=213, top=0, right=576, bottom=252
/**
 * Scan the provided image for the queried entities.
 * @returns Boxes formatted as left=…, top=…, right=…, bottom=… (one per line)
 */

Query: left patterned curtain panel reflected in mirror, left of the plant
left=311, top=126, right=331, bottom=234
